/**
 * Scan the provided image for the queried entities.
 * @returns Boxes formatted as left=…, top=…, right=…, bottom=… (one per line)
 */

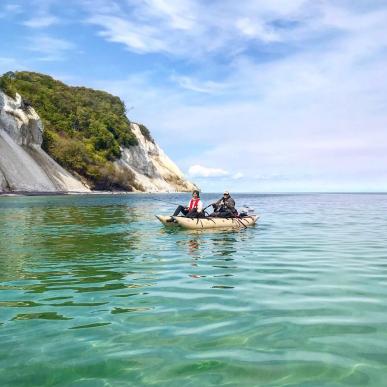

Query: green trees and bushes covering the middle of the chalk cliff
left=0, top=71, right=139, bottom=190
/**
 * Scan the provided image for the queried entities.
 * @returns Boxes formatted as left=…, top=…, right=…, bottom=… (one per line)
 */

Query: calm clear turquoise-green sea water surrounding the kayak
left=0, top=194, right=387, bottom=386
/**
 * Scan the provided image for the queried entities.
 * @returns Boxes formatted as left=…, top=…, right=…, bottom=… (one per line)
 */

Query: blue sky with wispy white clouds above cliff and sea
left=0, top=0, right=387, bottom=192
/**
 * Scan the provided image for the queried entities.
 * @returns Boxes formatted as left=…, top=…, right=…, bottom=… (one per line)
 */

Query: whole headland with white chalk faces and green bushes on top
left=0, top=72, right=196, bottom=192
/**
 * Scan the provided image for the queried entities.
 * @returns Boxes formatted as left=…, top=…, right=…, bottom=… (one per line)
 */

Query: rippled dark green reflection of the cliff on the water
left=0, top=197, right=164, bottom=327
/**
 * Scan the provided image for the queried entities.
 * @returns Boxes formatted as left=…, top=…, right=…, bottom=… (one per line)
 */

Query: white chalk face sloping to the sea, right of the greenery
left=116, top=123, right=197, bottom=192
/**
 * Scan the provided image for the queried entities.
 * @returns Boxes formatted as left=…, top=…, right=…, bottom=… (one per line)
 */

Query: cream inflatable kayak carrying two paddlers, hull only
left=156, top=215, right=259, bottom=230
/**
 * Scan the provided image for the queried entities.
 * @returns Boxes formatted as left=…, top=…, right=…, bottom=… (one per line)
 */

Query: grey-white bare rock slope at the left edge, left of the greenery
left=0, top=91, right=89, bottom=192
